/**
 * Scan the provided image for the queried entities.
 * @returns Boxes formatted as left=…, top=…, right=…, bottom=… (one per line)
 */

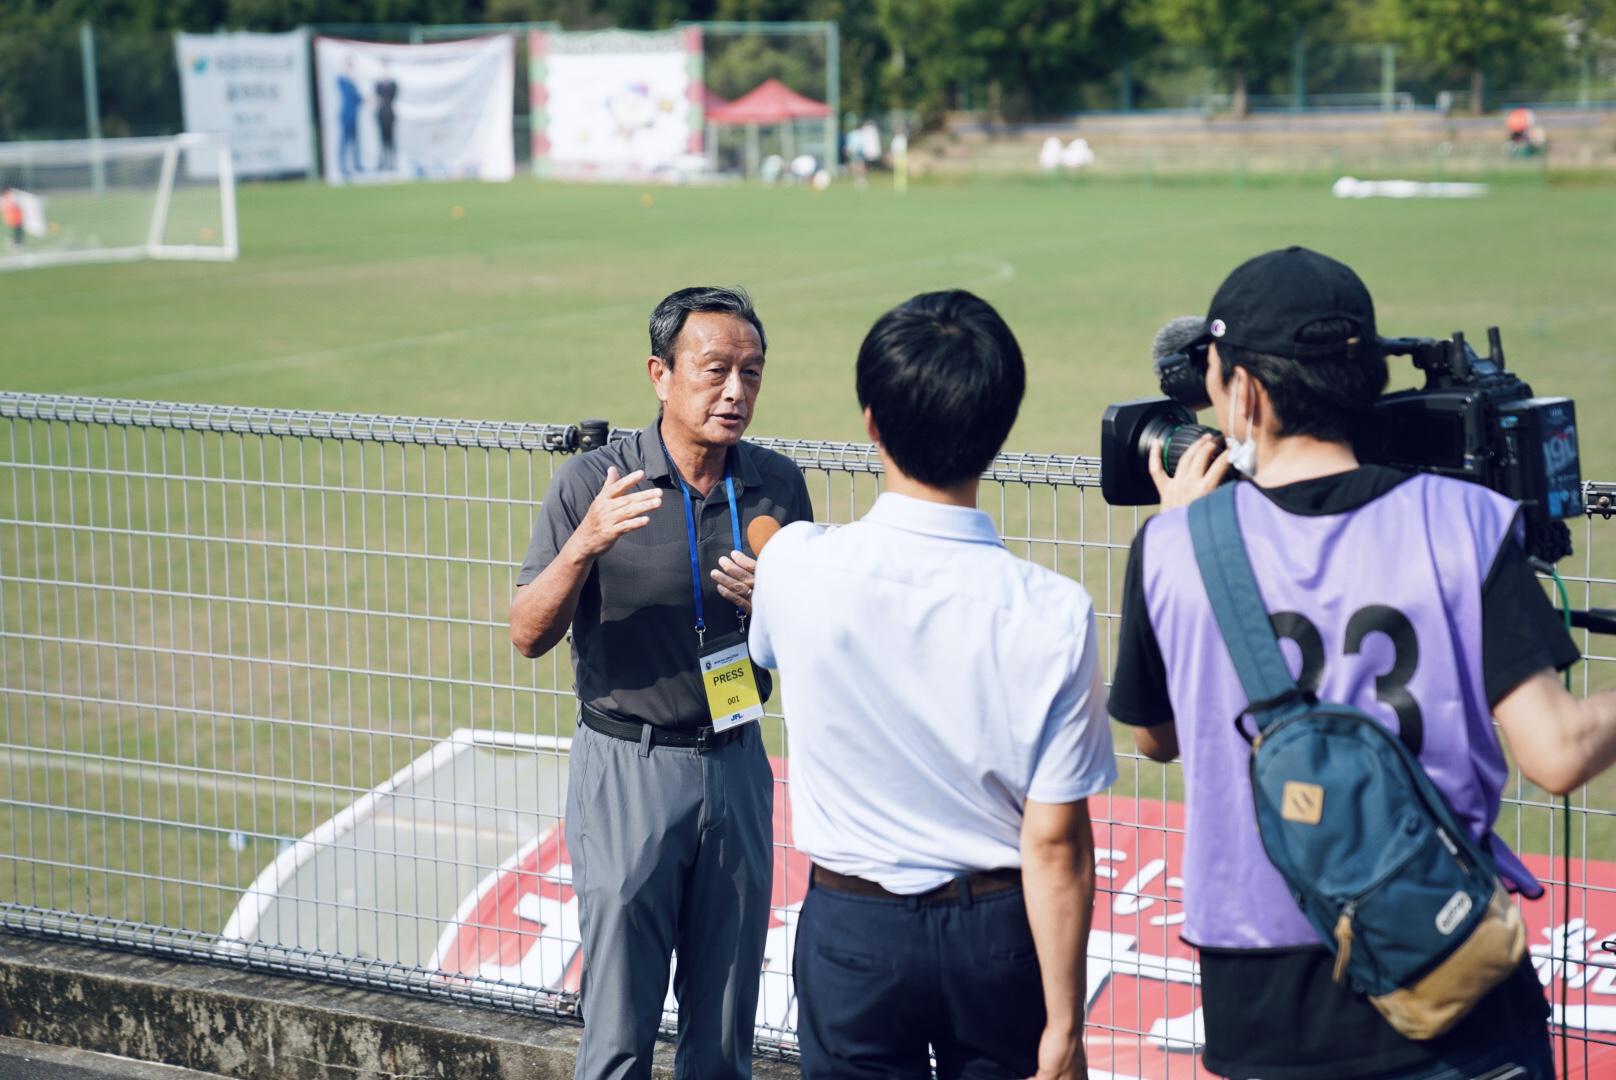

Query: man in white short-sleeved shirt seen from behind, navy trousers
left=750, top=291, right=1117, bottom=1080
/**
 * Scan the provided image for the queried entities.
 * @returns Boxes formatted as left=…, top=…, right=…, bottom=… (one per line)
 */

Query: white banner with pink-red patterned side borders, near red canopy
left=528, top=27, right=705, bottom=179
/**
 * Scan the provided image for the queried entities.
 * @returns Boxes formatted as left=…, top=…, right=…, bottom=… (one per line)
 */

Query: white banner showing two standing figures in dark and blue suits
left=314, top=34, right=516, bottom=184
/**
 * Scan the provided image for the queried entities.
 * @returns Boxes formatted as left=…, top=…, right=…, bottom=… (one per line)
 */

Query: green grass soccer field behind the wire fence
left=0, top=181, right=1616, bottom=931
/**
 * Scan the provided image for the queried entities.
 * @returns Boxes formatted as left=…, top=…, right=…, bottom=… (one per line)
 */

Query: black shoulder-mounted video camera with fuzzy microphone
left=1100, top=317, right=1584, bottom=563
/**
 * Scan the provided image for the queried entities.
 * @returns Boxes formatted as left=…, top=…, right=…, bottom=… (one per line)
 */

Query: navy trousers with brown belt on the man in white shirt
left=793, top=888, right=1044, bottom=1080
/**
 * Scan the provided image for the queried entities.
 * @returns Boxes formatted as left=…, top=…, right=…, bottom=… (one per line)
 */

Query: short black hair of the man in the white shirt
left=856, top=289, right=1026, bottom=488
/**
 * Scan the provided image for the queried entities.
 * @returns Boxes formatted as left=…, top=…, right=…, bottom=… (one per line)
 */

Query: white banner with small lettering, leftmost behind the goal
left=175, top=31, right=314, bottom=176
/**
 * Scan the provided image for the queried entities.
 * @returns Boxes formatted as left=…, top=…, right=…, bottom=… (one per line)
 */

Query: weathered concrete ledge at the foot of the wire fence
left=0, top=933, right=797, bottom=1080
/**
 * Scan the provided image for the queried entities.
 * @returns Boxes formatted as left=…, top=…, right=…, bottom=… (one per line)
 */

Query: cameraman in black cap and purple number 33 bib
left=1107, top=247, right=1616, bottom=1080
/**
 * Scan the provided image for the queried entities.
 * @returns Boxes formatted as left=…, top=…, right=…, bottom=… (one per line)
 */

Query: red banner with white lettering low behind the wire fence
left=428, top=779, right=1616, bottom=1080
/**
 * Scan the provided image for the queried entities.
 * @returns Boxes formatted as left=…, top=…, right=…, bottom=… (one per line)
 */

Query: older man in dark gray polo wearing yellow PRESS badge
left=511, top=288, right=813, bottom=1080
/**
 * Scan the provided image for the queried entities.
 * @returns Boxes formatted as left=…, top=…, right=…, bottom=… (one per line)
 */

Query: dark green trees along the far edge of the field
left=0, top=0, right=1616, bottom=137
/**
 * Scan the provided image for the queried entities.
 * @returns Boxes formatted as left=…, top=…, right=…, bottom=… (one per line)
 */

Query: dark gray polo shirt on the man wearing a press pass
left=516, top=417, right=813, bottom=728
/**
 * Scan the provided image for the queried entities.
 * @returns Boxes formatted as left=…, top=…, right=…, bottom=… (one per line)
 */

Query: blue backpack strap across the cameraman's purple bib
left=1189, top=483, right=1309, bottom=734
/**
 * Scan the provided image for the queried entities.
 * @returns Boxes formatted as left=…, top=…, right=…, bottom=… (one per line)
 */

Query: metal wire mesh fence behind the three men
left=0, top=393, right=1616, bottom=1075
